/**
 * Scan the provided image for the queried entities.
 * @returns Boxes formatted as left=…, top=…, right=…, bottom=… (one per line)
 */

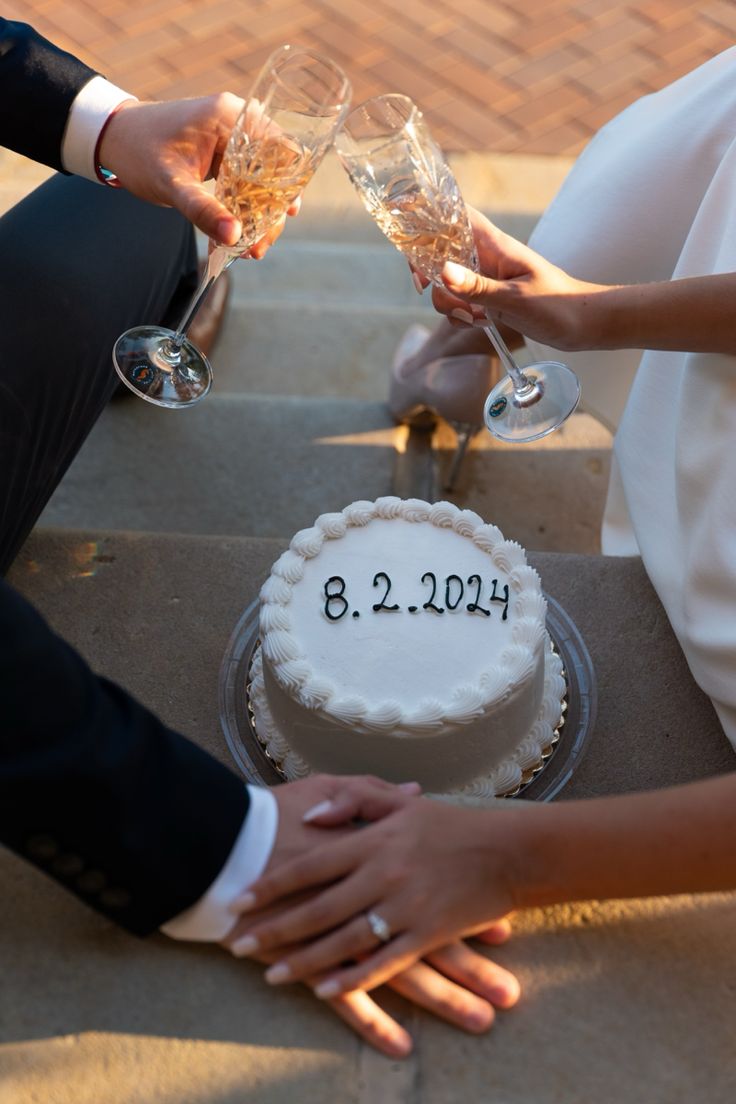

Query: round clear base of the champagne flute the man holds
left=113, top=326, right=212, bottom=410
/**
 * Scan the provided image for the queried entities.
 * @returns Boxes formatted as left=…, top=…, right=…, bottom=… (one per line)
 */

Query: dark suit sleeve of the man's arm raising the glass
left=0, top=19, right=96, bottom=171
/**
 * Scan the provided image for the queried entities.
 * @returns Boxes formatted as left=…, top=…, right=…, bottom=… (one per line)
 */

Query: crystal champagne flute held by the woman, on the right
left=335, top=93, right=580, bottom=442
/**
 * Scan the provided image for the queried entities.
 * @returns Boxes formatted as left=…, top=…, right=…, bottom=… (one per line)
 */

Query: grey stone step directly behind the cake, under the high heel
left=41, top=394, right=610, bottom=552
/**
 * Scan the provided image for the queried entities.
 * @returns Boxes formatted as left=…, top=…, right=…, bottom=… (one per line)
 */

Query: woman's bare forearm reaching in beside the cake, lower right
left=504, top=773, right=736, bottom=907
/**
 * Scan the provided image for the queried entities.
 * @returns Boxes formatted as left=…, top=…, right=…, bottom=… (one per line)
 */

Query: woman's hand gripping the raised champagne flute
left=433, top=208, right=609, bottom=350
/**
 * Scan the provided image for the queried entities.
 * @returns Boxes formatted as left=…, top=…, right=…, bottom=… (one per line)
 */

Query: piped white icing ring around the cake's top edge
left=260, top=496, right=546, bottom=736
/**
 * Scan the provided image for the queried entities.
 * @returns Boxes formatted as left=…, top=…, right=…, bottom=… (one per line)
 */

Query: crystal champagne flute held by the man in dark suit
left=113, top=45, right=351, bottom=410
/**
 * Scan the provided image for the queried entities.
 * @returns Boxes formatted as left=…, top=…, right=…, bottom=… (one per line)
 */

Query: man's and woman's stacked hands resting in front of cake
left=225, top=776, right=520, bottom=1053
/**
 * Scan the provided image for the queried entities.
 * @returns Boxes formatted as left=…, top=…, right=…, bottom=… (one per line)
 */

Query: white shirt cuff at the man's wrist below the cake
left=161, top=786, right=278, bottom=942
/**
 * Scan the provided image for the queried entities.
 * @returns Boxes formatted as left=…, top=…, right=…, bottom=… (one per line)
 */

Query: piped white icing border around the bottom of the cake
left=247, top=637, right=567, bottom=799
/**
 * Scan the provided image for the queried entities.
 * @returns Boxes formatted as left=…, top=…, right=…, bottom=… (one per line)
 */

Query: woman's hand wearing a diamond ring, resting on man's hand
left=227, top=782, right=524, bottom=998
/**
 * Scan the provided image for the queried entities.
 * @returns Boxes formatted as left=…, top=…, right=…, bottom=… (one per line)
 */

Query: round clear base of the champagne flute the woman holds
left=483, top=360, right=580, bottom=442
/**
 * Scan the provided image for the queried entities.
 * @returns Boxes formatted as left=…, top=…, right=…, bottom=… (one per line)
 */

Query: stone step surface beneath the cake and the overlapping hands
left=0, top=531, right=736, bottom=1104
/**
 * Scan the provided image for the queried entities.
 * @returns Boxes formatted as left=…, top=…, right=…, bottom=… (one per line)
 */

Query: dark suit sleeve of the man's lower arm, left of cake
left=0, top=580, right=248, bottom=935
